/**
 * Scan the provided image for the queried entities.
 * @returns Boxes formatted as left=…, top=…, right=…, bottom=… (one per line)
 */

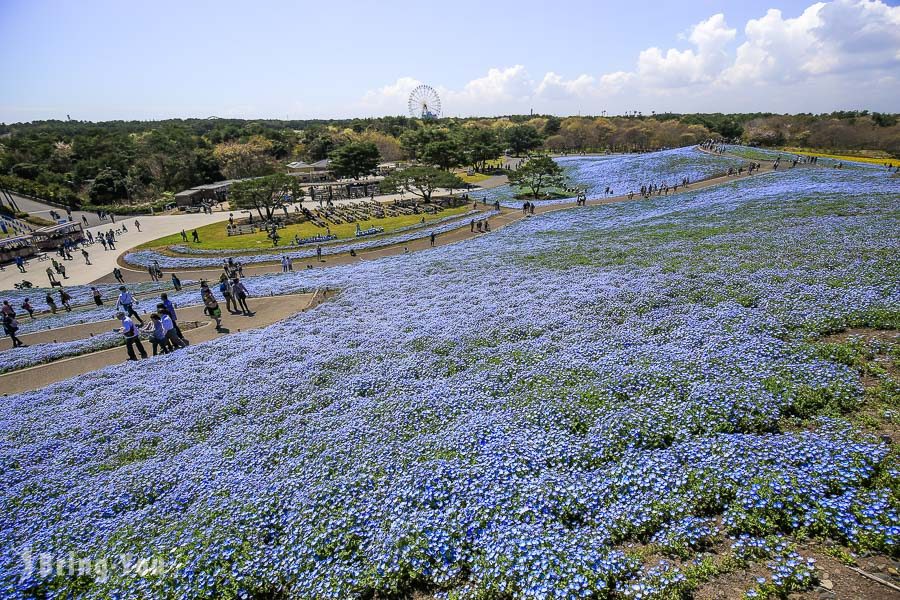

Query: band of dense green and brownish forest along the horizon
left=0, top=111, right=900, bottom=206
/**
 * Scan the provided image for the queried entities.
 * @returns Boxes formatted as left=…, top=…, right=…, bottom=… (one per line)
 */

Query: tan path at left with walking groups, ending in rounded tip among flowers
left=0, top=291, right=336, bottom=395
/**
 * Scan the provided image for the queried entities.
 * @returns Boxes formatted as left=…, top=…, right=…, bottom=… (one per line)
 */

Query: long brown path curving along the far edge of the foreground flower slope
left=100, top=157, right=796, bottom=283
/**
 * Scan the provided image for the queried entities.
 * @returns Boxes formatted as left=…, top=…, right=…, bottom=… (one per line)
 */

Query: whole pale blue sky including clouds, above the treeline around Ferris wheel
left=0, top=0, right=900, bottom=122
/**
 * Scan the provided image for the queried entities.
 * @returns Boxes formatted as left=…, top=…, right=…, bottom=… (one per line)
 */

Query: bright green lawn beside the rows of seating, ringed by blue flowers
left=138, top=204, right=469, bottom=250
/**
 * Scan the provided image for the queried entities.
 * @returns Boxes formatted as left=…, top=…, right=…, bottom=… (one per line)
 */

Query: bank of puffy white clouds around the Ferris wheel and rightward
left=363, top=0, right=900, bottom=115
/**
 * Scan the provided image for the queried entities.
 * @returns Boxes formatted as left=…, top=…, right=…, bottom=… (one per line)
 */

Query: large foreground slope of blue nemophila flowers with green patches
left=0, top=156, right=900, bottom=598
